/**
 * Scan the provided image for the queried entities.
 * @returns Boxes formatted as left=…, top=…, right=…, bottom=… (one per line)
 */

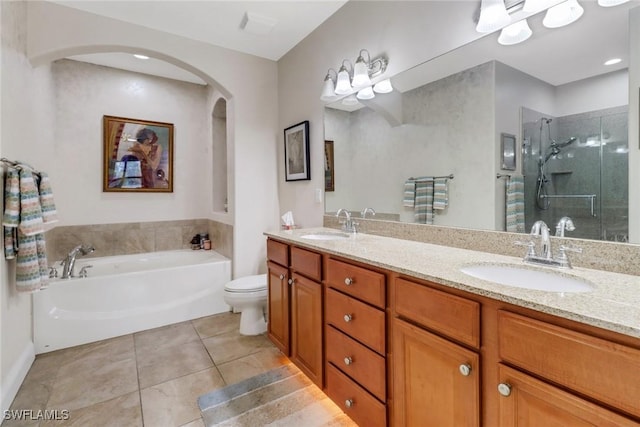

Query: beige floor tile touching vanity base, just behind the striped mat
left=218, top=348, right=290, bottom=384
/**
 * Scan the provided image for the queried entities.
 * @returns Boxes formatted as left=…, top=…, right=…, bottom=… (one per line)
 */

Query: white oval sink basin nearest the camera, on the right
left=460, top=264, right=595, bottom=292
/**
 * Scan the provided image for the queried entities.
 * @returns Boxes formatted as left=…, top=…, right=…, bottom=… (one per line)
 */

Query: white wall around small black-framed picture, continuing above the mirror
left=278, top=1, right=488, bottom=226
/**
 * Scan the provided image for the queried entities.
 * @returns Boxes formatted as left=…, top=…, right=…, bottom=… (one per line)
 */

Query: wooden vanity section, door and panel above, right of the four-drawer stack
left=392, top=278, right=480, bottom=427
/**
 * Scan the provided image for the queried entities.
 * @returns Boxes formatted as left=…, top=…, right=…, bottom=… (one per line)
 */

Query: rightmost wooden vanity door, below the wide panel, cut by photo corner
left=496, top=365, right=640, bottom=427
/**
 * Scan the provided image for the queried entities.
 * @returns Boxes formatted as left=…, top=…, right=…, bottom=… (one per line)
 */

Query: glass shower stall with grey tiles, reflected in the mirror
left=522, top=106, right=629, bottom=242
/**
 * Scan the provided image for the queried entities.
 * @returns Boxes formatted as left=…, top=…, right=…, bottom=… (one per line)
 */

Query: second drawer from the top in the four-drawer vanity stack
left=325, top=288, right=385, bottom=355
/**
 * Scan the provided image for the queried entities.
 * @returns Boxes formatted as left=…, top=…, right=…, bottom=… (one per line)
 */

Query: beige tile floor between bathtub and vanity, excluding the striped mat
left=2, top=313, right=296, bottom=427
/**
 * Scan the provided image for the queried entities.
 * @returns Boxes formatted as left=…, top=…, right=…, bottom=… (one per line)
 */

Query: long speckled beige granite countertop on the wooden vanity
left=264, top=228, right=640, bottom=338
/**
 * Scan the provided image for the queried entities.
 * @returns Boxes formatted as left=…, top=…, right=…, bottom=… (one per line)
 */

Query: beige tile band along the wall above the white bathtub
left=46, top=219, right=233, bottom=263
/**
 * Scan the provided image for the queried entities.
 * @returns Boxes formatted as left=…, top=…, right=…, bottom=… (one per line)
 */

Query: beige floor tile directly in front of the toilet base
left=202, top=332, right=273, bottom=365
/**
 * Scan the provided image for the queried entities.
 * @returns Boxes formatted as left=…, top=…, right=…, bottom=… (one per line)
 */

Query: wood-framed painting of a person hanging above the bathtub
left=102, top=116, right=173, bottom=193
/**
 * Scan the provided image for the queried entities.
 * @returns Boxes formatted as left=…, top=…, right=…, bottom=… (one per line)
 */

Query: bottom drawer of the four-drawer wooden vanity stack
left=327, top=364, right=387, bottom=427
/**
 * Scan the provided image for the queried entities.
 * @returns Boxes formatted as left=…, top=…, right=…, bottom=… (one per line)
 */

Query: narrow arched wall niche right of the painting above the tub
left=211, top=98, right=229, bottom=216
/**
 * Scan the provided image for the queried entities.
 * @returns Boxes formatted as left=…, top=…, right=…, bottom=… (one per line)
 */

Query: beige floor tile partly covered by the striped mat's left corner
left=141, top=368, right=225, bottom=427
